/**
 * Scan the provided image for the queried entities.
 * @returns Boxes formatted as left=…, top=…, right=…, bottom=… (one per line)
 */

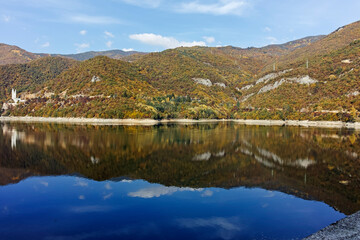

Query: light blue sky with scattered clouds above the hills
left=0, top=0, right=360, bottom=53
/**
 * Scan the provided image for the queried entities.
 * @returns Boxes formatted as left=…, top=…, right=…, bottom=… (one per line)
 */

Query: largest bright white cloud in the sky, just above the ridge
left=129, top=33, right=206, bottom=48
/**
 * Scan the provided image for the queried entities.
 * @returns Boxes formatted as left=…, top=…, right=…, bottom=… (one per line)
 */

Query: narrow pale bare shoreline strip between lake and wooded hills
left=0, top=116, right=360, bottom=129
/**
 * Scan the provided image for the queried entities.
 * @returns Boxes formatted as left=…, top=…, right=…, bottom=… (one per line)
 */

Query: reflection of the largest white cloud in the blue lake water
left=128, top=186, right=203, bottom=198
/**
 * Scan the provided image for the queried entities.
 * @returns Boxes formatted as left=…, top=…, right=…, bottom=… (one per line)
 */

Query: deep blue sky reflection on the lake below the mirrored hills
left=0, top=176, right=344, bottom=240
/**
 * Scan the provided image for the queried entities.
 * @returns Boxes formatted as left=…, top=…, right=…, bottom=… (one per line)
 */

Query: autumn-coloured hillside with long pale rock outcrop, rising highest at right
left=240, top=22, right=360, bottom=121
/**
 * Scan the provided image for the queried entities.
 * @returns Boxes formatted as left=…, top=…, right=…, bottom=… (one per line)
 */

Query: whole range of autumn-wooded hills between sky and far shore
left=0, top=19, right=360, bottom=121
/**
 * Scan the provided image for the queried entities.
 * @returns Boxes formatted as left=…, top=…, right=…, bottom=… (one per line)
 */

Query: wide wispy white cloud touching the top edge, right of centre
left=178, top=0, right=248, bottom=16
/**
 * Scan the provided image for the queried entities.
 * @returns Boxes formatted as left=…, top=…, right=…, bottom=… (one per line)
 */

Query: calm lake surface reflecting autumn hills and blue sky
left=0, top=123, right=360, bottom=240
